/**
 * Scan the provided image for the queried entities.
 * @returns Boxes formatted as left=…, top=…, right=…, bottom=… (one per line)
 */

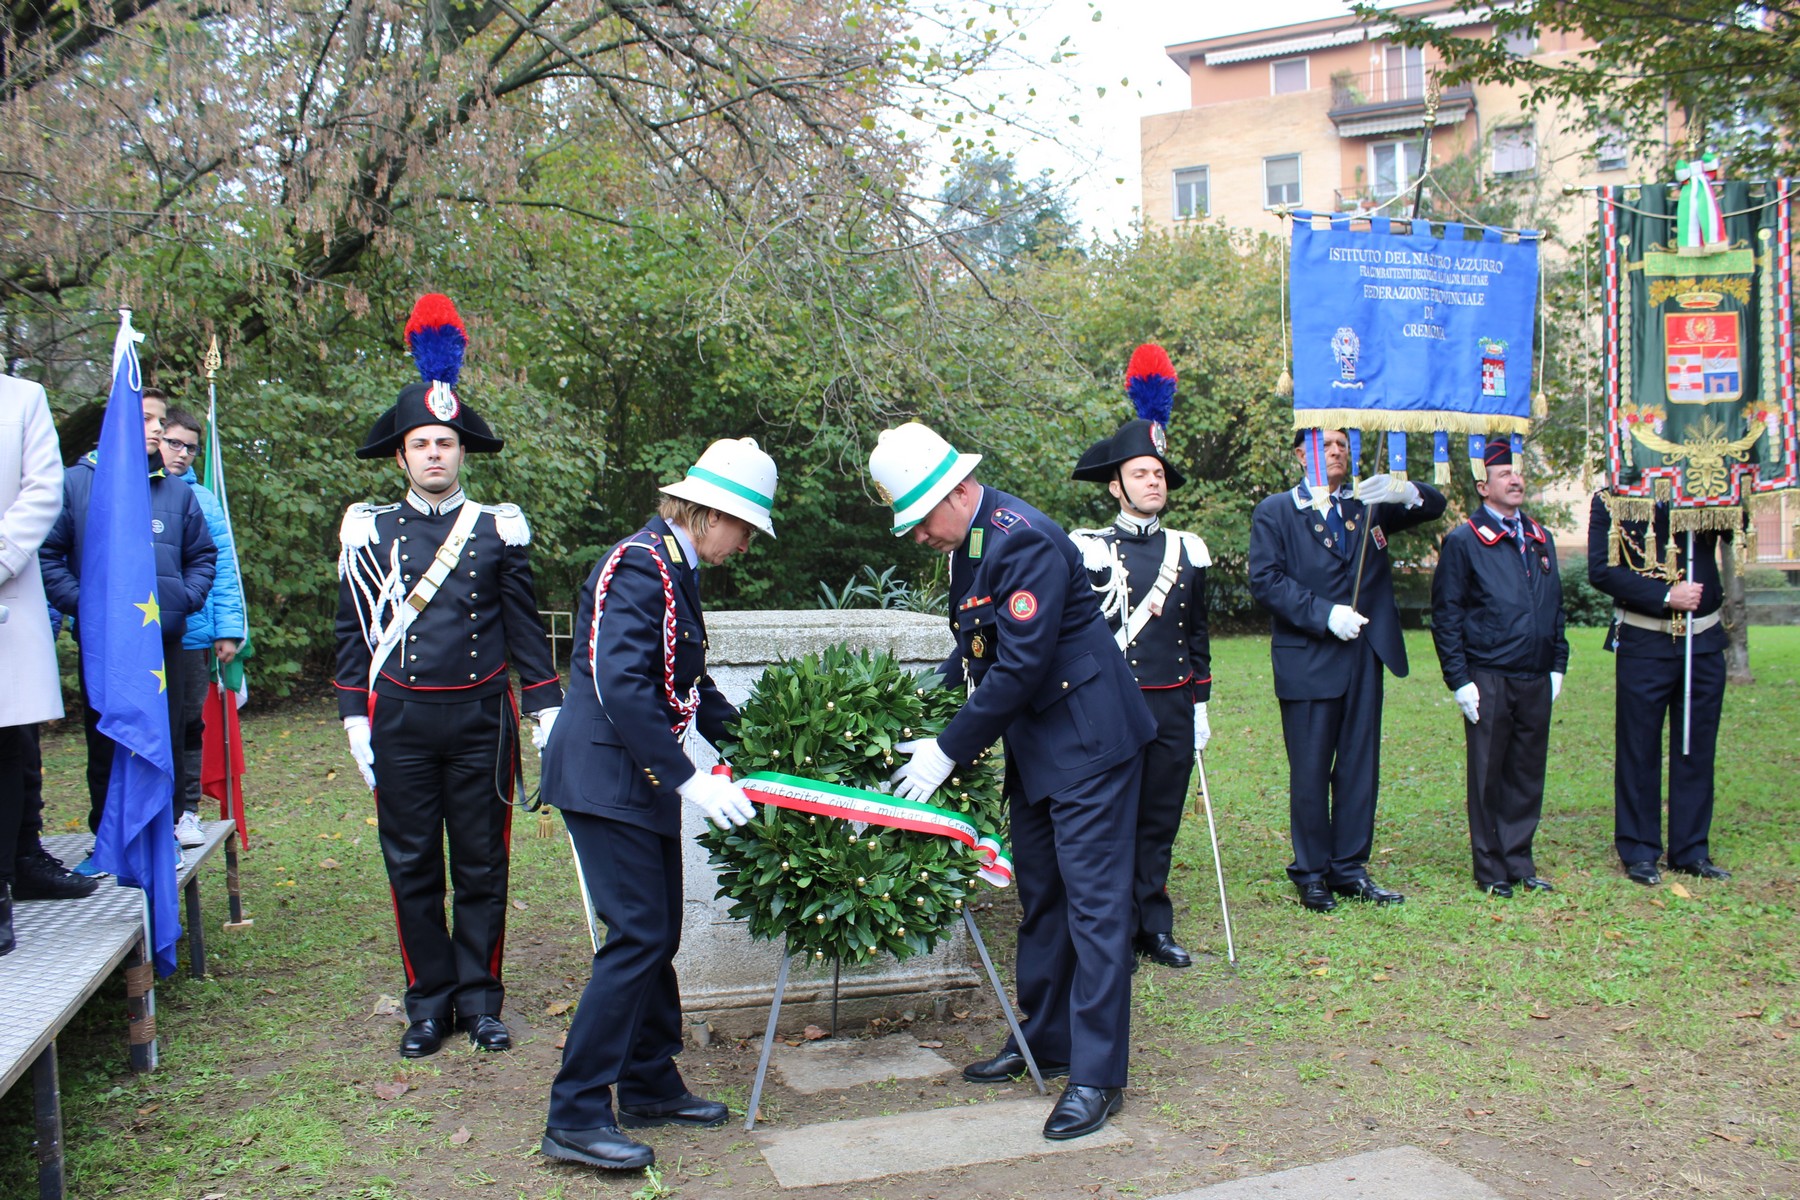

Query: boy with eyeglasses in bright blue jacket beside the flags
left=162, top=408, right=248, bottom=846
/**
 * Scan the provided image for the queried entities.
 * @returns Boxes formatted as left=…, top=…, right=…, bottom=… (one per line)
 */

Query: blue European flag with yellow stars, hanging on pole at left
left=77, top=311, right=182, bottom=975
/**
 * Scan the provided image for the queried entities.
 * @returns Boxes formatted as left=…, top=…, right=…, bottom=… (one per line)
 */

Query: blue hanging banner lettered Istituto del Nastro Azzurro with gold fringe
left=1291, top=212, right=1537, bottom=434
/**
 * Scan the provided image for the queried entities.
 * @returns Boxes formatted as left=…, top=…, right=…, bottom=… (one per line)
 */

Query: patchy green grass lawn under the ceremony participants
left=0, top=628, right=1800, bottom=1200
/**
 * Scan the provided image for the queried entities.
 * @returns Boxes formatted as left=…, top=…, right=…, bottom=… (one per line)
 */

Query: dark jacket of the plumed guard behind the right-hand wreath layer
left=1089, top=524, right=1213, bottom=703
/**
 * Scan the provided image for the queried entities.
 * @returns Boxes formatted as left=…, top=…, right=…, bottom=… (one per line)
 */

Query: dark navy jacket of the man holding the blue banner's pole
left=1249, top=484, right=1444, bottom=700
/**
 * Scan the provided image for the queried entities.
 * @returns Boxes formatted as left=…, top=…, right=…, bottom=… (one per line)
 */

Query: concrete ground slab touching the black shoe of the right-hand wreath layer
left=756, top=1097, right=1130, bottom=1187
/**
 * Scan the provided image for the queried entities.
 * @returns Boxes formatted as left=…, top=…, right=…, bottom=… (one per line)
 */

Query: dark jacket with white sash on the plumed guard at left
left=335, top=491, right=562, bottom=716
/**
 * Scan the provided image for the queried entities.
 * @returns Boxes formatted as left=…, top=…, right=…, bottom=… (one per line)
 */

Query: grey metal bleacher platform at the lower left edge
left=0, top=820, right=248, bottom=1200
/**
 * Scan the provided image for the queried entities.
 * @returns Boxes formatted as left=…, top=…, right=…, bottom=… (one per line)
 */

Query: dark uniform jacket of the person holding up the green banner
left=1588, top=491, right=1728, bottom=658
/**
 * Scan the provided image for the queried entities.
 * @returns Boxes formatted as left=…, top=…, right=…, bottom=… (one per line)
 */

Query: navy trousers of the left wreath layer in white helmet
left=547, top=808, right=686, bottom=1130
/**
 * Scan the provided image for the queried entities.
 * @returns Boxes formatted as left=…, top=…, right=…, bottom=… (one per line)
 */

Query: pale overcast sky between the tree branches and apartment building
left=981, top=0, right=1350, bottom=236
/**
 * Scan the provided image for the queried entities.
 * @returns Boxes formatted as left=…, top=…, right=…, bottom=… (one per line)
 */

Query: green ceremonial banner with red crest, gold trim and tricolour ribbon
left=1600, top=176, right=1800, bottom=529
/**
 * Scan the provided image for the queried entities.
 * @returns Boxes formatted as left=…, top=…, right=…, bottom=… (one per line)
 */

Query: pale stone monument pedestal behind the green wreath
left=675, top=608, right=986, bottom=1038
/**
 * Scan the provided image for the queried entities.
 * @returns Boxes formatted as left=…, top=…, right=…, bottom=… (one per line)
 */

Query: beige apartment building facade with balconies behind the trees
left=1139, top=0, right=1636, bottom=232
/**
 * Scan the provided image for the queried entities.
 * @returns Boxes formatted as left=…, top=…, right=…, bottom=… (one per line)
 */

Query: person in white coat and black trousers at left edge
left=0, top=376, right=63, bottom=954
